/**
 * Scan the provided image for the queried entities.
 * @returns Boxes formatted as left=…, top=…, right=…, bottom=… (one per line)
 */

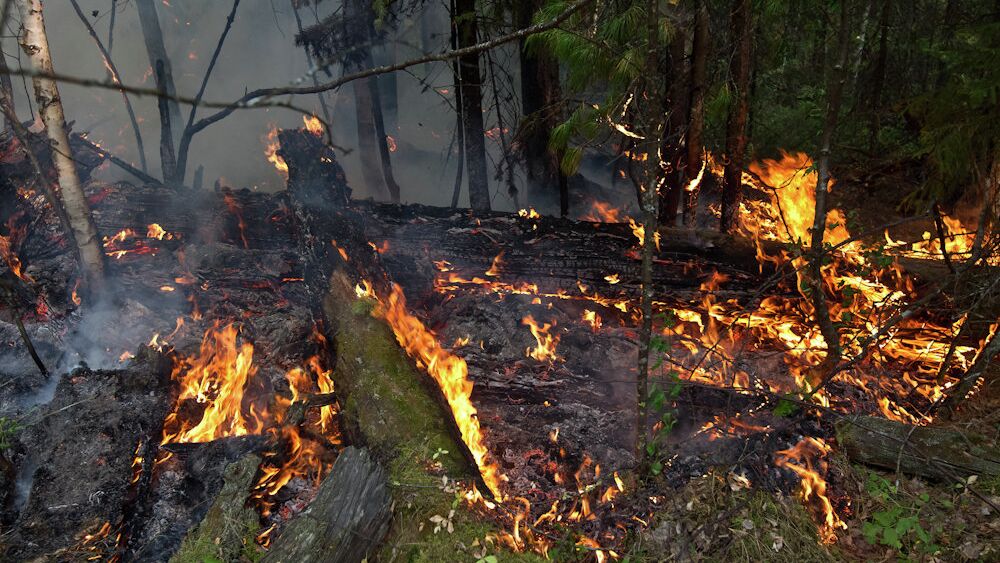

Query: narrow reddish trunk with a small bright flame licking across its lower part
left=684, top=0, right=709, bottom=227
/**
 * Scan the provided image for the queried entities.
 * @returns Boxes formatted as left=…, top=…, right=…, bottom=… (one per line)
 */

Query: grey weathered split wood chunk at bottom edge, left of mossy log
left=263, top=447, right=392, bottom=563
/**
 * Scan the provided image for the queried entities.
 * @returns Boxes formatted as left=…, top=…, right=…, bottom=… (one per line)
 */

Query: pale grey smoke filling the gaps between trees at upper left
left=2, top=0, right=540, bottom=210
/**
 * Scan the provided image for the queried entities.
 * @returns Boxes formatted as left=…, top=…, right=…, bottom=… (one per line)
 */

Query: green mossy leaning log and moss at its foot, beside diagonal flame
left=323, top=271, right=540, bottom=562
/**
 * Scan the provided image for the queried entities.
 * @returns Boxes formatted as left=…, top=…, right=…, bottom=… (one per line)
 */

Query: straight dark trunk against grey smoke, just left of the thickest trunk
left=451, top=0, right=490, bottom=211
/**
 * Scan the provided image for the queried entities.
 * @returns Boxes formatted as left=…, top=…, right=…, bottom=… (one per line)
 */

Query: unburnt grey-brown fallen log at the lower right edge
left=837, top=416, right=1000, bottom=480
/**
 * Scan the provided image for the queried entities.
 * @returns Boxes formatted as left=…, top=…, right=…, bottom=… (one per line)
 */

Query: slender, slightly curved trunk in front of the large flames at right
left=808, top=1, right=850, bottom=389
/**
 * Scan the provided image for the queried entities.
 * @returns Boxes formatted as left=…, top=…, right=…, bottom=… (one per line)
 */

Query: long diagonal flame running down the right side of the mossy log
left=374, top=281, right=502, bottom=498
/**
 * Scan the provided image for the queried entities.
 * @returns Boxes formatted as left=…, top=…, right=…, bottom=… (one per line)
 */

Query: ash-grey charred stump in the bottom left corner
left=4, top=349, right=171, bottom=561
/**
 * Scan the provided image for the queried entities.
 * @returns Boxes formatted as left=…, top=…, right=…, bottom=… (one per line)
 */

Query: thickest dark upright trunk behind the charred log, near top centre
left=517, top=0, right=569, bottom=216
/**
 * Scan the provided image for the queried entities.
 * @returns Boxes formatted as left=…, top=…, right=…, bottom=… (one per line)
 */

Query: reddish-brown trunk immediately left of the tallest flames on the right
left=720, top=0, right=752, bottom=233
